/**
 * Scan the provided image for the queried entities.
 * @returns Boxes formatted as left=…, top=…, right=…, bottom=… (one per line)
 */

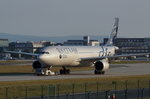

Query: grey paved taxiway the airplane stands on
left=0, top=63, right=150, bottom=81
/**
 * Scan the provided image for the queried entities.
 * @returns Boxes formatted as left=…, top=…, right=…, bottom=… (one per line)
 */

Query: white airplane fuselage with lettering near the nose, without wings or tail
left=38, top=46, right=116, bottom=66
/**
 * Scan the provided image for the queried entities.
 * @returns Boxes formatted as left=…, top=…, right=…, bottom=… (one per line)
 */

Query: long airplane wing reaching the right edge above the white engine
left=78, top=53, right=150, bottom=61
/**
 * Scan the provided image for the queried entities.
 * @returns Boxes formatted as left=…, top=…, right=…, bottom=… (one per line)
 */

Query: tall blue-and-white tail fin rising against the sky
left=106, top=18, right=119, bottom=46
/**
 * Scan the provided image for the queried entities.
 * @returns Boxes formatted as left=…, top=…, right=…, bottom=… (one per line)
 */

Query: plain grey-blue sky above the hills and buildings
left=0, top=0, right=150, bottom=37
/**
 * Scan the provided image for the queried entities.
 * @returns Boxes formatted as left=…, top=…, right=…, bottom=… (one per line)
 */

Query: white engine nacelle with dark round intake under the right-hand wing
left=95, top=60, right=109, bottom=71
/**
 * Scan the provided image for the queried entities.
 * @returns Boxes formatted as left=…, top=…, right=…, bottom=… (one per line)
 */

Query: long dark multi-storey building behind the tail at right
left=104, top=38, right=150, bottom=54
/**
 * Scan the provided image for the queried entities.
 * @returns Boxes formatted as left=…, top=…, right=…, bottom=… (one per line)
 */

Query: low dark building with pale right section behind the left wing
left=9, top=41, right=57, bottom=59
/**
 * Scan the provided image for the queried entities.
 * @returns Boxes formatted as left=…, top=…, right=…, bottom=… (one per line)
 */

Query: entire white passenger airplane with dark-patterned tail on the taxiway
left=5, top=18, right=150, bottom=75
